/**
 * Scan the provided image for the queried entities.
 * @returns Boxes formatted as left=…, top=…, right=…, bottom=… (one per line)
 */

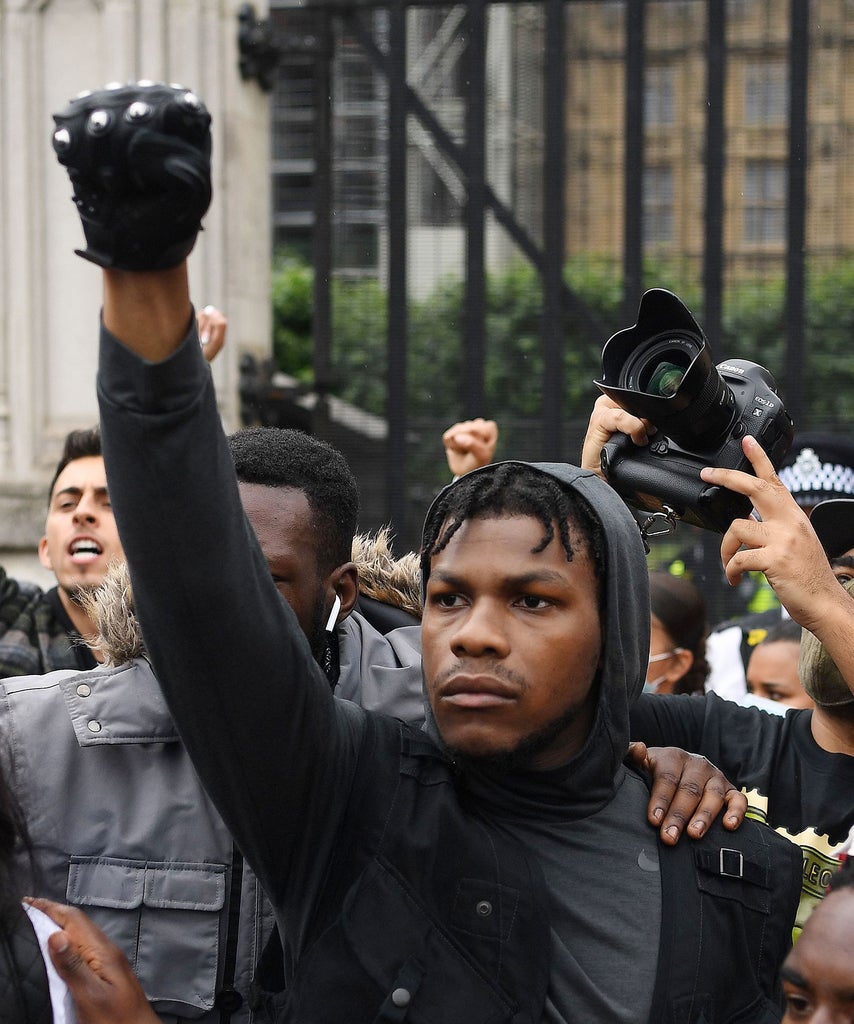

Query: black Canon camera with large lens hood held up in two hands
left=596, top=288, right=794, bottom=534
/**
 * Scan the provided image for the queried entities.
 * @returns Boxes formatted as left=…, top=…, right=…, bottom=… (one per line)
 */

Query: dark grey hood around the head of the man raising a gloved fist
left=421, top=462, right=649, bottom=811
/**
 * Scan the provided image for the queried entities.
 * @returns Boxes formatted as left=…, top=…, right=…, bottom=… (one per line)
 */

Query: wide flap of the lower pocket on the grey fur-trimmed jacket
left=67, top=857, right=225, bottom=911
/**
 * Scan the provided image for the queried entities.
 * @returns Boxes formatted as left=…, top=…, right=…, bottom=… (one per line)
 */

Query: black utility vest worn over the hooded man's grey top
left=256, top=723, right=801, bottom=1024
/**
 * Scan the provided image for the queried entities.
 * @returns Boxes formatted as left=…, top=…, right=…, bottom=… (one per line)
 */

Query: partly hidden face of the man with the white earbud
left=239, top=483, right=326, bottom=653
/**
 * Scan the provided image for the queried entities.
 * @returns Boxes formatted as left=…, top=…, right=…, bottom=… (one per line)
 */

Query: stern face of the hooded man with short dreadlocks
left=421, top=516, right=602, bottom=769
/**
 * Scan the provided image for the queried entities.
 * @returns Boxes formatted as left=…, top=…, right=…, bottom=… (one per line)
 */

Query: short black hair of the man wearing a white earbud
left=228, top=427, right=358, bottom=569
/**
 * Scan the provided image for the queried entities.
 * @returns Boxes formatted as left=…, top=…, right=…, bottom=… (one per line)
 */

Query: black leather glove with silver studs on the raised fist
left=53, top=82, right=211, bottom=270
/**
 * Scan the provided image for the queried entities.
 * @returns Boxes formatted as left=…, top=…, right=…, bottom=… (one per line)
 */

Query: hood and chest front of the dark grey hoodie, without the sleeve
left=422, top=463, right=660, bottom=1024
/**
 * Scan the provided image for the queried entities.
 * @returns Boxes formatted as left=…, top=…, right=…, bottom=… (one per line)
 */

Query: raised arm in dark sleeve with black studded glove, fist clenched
left=54, top=86, right=360, bottom=902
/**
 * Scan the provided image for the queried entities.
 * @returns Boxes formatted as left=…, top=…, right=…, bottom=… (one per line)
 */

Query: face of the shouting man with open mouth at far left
left=39, top=456, right=124, bottom=599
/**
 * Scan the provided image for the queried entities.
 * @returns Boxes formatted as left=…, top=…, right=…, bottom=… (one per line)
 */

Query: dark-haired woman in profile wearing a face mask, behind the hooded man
left=643, top=571, right=709, bottom=693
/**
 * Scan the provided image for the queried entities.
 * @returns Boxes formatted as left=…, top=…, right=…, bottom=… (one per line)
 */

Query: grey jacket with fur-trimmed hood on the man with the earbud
left=0, top=538, right=423, bottom=1024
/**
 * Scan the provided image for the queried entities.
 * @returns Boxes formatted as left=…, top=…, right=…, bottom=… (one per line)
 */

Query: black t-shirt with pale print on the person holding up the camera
left=632, top=693, right=854, bottom=934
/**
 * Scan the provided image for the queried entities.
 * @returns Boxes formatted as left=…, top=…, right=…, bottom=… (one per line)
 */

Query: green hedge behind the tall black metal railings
left=272, top=257, right=854, bottom=426
